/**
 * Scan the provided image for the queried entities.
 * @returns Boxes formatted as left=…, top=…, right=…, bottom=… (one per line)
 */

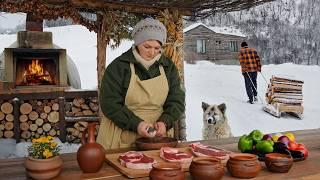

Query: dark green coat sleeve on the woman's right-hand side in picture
left=158, top=61, right=185, bottom=129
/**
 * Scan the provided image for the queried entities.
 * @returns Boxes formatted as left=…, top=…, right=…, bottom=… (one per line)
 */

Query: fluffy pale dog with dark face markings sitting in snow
left=202, top=102, right=232, bottom=140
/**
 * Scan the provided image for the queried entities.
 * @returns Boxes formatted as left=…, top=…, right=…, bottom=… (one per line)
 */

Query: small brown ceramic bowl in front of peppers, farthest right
left=264, top=153, right=293, bottom=173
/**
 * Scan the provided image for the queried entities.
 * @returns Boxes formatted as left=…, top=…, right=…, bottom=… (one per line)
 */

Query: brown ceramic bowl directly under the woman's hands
left=135, top=137, right=178, bottom=151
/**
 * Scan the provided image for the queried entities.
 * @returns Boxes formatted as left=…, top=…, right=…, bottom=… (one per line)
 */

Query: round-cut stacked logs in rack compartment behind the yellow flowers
left=19, top=99, right=60, bottom=141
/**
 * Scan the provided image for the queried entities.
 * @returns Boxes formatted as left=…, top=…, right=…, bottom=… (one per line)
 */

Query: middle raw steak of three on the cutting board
left=160, top=147, right=193, bottom=163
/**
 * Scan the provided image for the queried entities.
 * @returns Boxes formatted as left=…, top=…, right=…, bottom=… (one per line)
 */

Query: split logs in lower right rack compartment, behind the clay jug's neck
left=67, top=121, right=99, bottom=143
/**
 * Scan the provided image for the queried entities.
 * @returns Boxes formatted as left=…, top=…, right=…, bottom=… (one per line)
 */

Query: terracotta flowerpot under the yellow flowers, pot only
left=25, top=156, right=63, bottom=180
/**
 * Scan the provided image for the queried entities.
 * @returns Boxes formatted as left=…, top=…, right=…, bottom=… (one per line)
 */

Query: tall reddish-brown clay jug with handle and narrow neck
left=77, top=123, right=105, bottom=173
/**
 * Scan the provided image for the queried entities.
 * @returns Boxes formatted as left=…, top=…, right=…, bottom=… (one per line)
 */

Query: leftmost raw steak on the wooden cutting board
left=119, top=151, right=157, bottom=169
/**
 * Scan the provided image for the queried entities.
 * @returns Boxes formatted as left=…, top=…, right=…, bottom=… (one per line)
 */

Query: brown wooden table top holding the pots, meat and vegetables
left=0, top=129, right=320, bottom=180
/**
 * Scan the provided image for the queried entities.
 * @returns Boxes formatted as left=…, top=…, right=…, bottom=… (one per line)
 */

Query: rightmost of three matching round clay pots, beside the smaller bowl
left=227, top=153, right=261, bottom=178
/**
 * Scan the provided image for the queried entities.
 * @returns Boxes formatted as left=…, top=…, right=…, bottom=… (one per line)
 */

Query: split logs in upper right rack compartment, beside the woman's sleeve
left=65, top=97, right=99, bottom=116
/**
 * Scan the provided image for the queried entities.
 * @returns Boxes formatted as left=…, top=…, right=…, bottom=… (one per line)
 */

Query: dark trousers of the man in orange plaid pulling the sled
left=242, top=72, right=258, bottom=102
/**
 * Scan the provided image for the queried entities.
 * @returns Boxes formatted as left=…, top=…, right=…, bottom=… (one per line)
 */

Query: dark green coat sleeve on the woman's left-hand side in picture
left=99, top=62, right=142, bottom=132
